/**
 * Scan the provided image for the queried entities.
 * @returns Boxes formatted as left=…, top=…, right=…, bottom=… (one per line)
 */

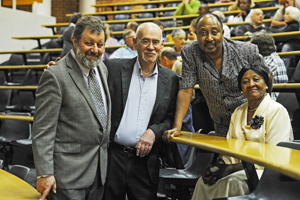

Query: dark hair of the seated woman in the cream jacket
left=238, top=65, right=269, bottom=91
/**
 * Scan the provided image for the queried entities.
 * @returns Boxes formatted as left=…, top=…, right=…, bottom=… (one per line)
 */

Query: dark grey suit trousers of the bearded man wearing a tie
left=47, top=164, right=104, bottom=200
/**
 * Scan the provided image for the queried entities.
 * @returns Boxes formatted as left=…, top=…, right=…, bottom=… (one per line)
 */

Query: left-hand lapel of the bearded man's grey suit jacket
left=66, top=53, right=101, bottom=124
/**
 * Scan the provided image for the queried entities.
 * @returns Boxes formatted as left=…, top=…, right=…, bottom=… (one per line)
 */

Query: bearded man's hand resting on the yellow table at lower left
left=36, top=175, right=56, bottom=200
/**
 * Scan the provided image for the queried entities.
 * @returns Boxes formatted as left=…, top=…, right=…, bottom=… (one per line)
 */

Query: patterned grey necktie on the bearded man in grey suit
left=88, top=69, right=107, bottom=129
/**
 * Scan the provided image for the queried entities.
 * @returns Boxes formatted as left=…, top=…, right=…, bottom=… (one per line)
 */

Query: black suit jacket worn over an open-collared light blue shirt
left=105, top=58, right=179, bottom=183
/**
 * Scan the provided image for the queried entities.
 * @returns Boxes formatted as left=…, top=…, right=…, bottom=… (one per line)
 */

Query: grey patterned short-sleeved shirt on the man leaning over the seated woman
left=180, top=38, right=262, bottom=136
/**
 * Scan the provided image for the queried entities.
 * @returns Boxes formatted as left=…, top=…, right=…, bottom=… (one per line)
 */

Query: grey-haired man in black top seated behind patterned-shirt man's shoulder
left=235, top=9, right=271, bottom=36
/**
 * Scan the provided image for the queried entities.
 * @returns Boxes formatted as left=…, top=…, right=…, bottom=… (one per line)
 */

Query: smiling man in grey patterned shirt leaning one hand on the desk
left=163, top=13, right=271, bottom=140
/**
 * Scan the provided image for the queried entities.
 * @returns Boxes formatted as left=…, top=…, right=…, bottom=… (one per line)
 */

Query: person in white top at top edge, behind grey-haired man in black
left=227, top=0, right=252, bottom=23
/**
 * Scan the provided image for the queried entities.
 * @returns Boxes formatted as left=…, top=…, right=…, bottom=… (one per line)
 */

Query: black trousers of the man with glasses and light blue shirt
left=104, top=146, right=158, bottom=200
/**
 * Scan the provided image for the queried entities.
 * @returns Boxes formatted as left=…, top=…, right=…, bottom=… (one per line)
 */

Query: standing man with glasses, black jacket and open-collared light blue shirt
left=104, top=22, right=179, bottom=200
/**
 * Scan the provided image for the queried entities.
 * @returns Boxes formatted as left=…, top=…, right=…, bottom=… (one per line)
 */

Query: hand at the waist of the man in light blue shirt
left=135, top=129, right=155, bottom=157
